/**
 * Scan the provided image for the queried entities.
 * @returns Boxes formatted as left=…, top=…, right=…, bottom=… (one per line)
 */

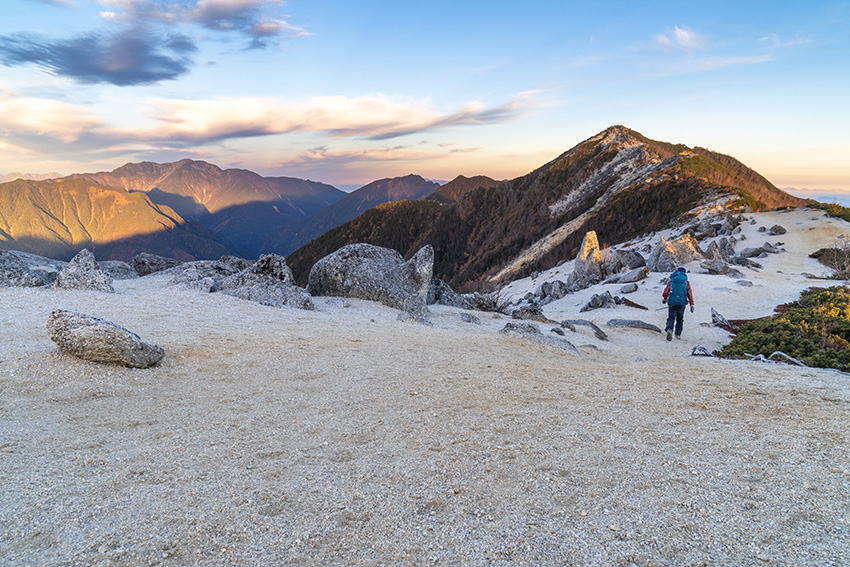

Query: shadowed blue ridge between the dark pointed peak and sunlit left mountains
left=262, top=174, right=440, bottom=255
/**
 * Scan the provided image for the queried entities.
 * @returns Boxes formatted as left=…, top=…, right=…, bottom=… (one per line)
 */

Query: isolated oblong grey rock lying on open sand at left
left=47, top=310, right=165, bottom=368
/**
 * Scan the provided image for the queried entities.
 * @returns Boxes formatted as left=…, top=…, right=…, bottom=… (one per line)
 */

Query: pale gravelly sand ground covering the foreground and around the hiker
left=0, top=209, right=850, bottom=567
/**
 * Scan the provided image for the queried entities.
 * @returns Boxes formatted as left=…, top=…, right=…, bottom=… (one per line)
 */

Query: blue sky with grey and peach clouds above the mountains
left=0, top=0, right=850, bottom=192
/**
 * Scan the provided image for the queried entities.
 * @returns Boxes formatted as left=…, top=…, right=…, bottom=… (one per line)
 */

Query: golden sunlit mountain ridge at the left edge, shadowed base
left=0, top=179, right=234, bottom=261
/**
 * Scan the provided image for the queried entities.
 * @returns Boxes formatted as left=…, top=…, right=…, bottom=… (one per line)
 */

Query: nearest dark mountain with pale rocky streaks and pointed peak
left=287, top=126, right=806, bottom=287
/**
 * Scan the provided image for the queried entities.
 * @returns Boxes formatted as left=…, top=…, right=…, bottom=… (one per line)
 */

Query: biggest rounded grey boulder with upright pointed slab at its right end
left=307, top=244, right=434, bottom=316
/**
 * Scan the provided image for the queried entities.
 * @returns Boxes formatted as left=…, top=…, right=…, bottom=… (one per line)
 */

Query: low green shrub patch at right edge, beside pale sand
left=717, top=286, right=850, bottom=372
